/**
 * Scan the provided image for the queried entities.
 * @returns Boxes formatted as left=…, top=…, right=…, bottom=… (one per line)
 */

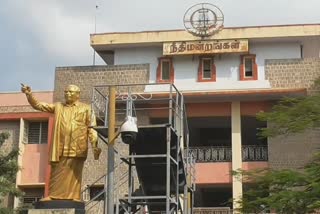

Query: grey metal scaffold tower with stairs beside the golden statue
left=92, top=84, right=195, bottom=214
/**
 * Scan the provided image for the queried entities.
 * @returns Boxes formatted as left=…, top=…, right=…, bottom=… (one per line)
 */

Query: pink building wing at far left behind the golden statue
left=0, top=92, right=53, bottom=207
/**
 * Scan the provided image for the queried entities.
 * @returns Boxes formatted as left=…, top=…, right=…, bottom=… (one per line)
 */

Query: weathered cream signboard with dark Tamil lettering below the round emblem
left=163, top=39, right=249, bottom=55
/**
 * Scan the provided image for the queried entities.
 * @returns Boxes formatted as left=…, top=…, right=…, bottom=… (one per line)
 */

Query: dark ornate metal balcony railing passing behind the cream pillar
left=189, top=145, right=268, bottom=163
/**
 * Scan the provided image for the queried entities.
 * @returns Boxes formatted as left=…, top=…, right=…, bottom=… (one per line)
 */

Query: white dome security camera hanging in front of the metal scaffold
left=120, top=116, right=138, bottom=144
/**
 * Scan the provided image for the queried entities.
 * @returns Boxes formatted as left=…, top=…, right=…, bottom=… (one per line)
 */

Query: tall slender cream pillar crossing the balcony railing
left=231, top=102, right=242, bottom=209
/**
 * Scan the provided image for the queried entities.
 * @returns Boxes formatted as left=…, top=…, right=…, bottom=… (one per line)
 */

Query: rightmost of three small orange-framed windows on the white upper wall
left=240, top=54, right=258, bottom=80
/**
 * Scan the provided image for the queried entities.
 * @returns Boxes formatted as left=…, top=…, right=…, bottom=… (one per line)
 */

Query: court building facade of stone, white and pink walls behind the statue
left=0, top=24, right=320, bottom=210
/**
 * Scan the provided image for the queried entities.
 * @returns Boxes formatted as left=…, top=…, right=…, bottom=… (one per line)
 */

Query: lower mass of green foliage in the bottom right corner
left=238, top=154, right=320, bottom=214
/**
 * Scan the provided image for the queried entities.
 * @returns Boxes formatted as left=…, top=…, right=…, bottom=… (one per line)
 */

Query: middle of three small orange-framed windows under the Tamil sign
left=198, top=57, right=216, bottom=82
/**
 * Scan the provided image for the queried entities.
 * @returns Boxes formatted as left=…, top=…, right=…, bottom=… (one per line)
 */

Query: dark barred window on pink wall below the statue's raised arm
left=28, top=121, right=48, bottom=144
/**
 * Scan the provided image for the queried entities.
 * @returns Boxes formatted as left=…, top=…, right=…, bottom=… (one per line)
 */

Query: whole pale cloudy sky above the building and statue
left=0, top=0, right=320, bottom=92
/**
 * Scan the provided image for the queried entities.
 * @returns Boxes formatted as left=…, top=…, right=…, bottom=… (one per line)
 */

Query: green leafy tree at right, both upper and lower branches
left=237, top=79, right=320, bottom=213
